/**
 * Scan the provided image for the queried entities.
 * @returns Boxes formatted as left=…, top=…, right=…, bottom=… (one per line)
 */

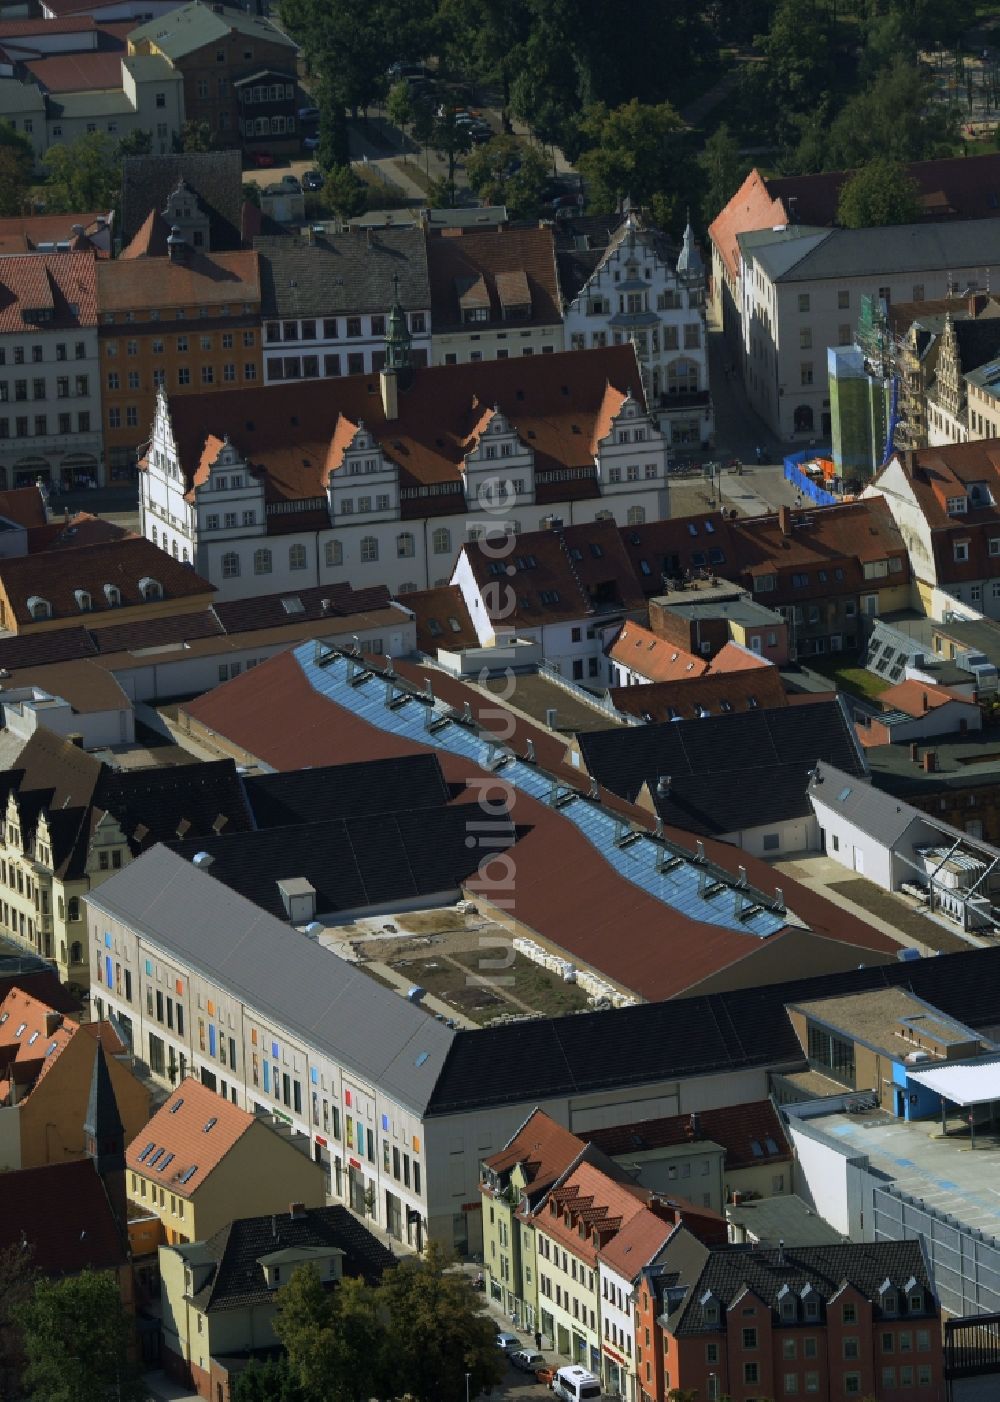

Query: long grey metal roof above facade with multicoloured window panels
left=88, top=847, right=454, bottom=1115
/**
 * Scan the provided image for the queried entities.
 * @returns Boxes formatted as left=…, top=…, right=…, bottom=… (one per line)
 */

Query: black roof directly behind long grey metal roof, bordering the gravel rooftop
left=167, top=805, right=513, bottom=920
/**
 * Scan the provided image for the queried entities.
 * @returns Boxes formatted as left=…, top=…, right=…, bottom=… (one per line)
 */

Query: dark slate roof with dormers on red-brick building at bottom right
left=662, top=1241, right=937, bottom=1335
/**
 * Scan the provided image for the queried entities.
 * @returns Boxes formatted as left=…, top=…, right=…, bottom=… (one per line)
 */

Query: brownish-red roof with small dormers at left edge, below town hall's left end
left=0, top=536, right=215, bottom=625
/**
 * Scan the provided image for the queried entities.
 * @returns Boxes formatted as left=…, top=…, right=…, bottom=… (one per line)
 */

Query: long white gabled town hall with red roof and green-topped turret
left=140, top=336, right=668, bottom=599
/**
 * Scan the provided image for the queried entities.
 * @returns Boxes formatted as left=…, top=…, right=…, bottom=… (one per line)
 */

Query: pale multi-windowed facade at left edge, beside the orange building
left=0, top=312, right=104, bottom=488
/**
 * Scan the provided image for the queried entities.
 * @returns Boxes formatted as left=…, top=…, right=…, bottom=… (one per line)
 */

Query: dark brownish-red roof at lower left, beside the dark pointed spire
left=0, top=1158, right=128, bottom=1276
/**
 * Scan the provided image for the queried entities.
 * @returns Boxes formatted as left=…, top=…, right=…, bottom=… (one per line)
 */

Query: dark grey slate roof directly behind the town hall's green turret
left=254, top=229, right=431, bottom=317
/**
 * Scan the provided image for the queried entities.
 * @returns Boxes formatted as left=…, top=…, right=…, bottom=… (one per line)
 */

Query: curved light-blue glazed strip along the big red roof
left=295, top=642, right=785, bottom=939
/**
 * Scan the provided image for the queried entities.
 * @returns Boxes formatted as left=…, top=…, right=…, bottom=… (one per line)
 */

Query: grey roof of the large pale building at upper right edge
left=762, top=219, right=1000, bottom=282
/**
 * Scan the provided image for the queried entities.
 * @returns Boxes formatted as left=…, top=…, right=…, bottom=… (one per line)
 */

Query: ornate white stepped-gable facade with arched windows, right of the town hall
left=564, top=213, right=714, bottom=447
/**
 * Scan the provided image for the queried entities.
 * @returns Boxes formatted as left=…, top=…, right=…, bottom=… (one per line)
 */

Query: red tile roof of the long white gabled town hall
left=155, top=343, right=641, bottom=513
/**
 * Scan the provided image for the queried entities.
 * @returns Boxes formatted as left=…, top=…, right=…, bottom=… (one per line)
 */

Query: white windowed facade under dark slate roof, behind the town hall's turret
left=264, top=309, right=431, bottom=384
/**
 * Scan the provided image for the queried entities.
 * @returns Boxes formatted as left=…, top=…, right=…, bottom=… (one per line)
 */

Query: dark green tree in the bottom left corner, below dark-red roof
left=17, top=1270, right=146, bottom=1402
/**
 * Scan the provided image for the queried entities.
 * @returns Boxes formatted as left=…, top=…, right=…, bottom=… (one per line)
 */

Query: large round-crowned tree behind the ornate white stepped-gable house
left=576, top=98, right=682, bottom=212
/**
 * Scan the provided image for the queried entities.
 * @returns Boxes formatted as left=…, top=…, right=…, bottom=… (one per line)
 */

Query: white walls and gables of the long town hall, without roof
left=139, top=381, right=668, bottom=600
